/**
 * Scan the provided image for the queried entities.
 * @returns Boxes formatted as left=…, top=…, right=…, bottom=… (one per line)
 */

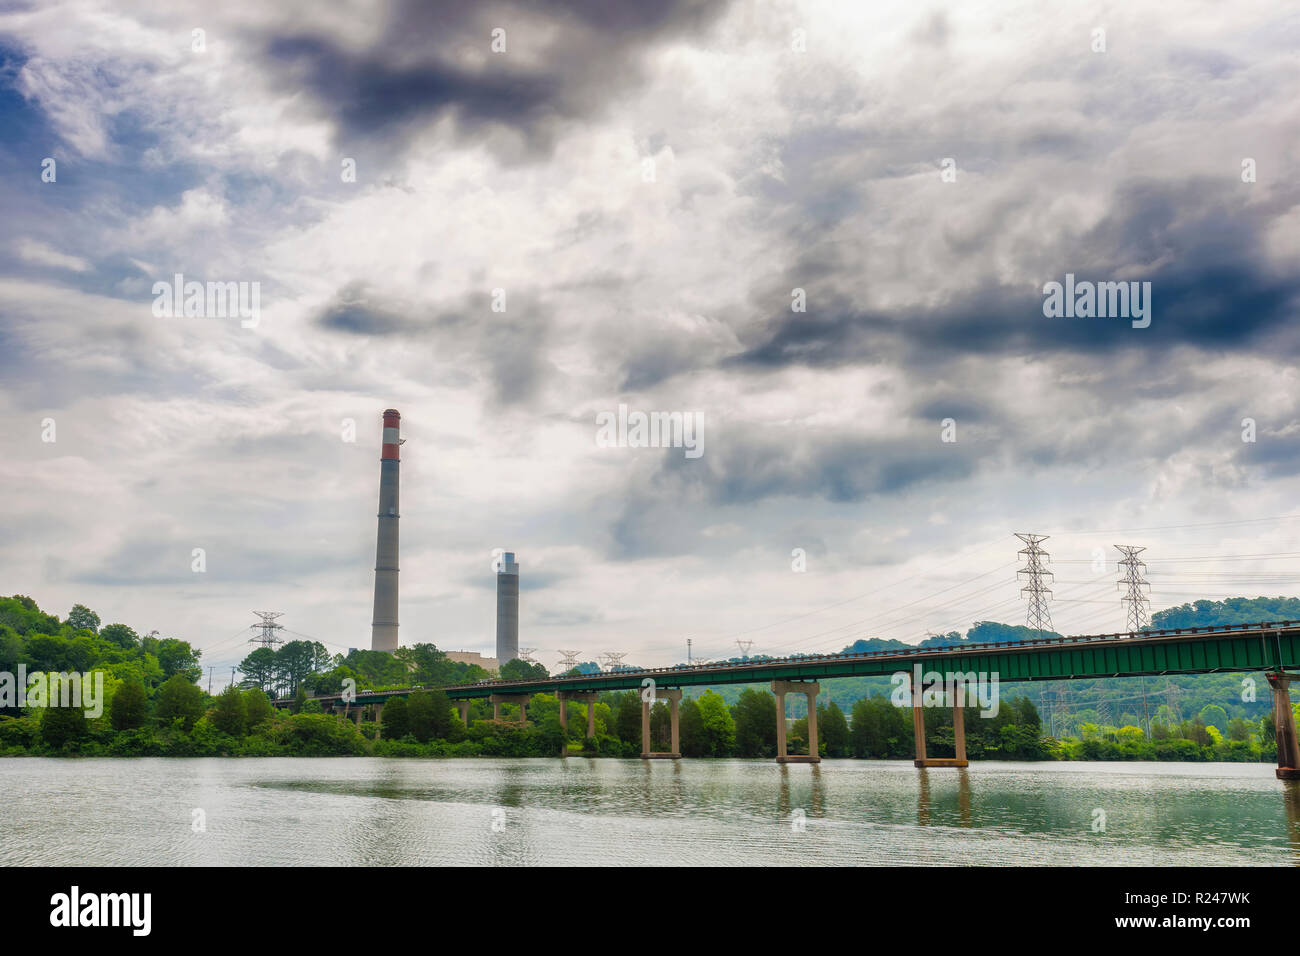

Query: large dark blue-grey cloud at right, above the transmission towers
left=723, top=181, right=1300, bottom=368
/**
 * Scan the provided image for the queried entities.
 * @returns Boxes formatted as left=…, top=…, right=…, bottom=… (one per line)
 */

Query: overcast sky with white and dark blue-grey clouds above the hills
left=0, top=0, right=1300, bottom=683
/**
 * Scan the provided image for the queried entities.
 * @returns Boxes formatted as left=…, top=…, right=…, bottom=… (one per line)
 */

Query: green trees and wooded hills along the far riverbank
left=0, top=596, right=1300, bottom=761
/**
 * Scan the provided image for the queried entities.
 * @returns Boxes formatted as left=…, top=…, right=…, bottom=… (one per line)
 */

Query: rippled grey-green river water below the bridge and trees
left=0, top=758, right=1300, bottom=866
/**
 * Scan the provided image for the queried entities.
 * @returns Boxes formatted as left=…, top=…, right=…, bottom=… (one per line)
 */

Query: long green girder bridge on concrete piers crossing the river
left=276, top=620, right=1300, bottom=779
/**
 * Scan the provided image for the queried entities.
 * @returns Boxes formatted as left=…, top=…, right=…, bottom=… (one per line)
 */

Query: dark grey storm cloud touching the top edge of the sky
left=267, top=0, right=727, bottom=157
